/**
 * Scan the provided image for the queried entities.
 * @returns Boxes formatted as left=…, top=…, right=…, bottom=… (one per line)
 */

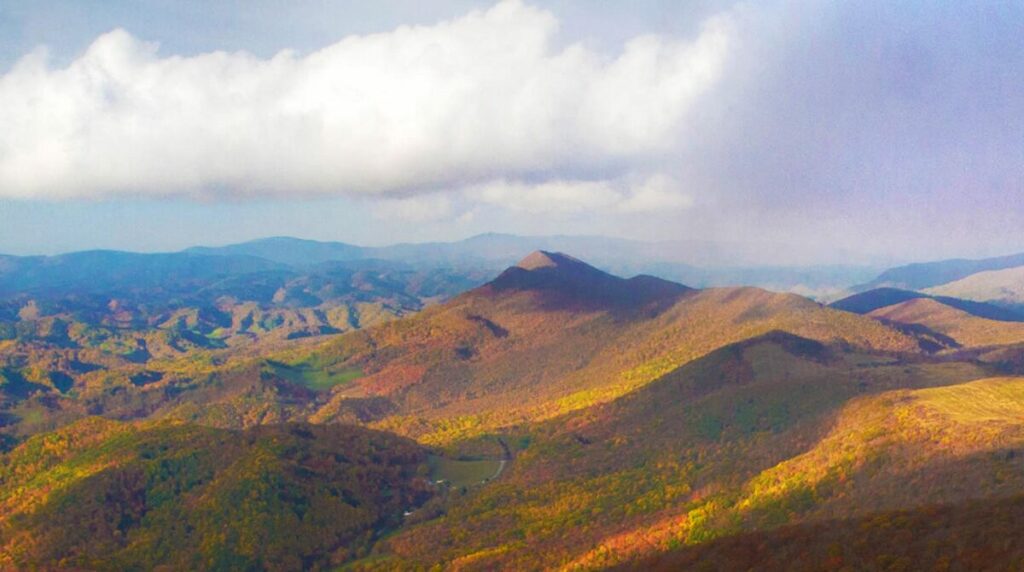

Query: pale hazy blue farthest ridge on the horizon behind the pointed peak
left=0, top=232, right=880, bottom=298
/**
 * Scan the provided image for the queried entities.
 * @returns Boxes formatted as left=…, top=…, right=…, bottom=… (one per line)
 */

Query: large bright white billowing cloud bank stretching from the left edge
left=0, top=0, right=732, bottom=201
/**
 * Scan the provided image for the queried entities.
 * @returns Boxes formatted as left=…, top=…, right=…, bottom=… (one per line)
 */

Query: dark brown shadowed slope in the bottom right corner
left=620, top=487, right=1024, bottom=571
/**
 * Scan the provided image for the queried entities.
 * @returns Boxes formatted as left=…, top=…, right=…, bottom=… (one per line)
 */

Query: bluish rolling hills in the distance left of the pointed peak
left=0, top=252, right=488, bottom=415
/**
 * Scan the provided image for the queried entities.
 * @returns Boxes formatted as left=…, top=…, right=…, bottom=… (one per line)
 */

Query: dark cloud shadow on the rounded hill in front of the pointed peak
left=520, top=331, right=856, bottom=488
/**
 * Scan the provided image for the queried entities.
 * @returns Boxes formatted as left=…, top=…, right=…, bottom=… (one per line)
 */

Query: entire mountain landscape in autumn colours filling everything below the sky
left=0, top=240, right=1024, bottom=570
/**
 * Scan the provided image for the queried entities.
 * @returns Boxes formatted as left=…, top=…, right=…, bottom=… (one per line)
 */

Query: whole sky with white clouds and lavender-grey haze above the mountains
left=0, top=0, right=1024, bottom=264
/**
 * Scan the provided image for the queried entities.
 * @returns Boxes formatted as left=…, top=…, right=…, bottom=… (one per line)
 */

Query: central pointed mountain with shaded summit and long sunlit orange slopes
left=2, top=252, right=921, bottom=444
